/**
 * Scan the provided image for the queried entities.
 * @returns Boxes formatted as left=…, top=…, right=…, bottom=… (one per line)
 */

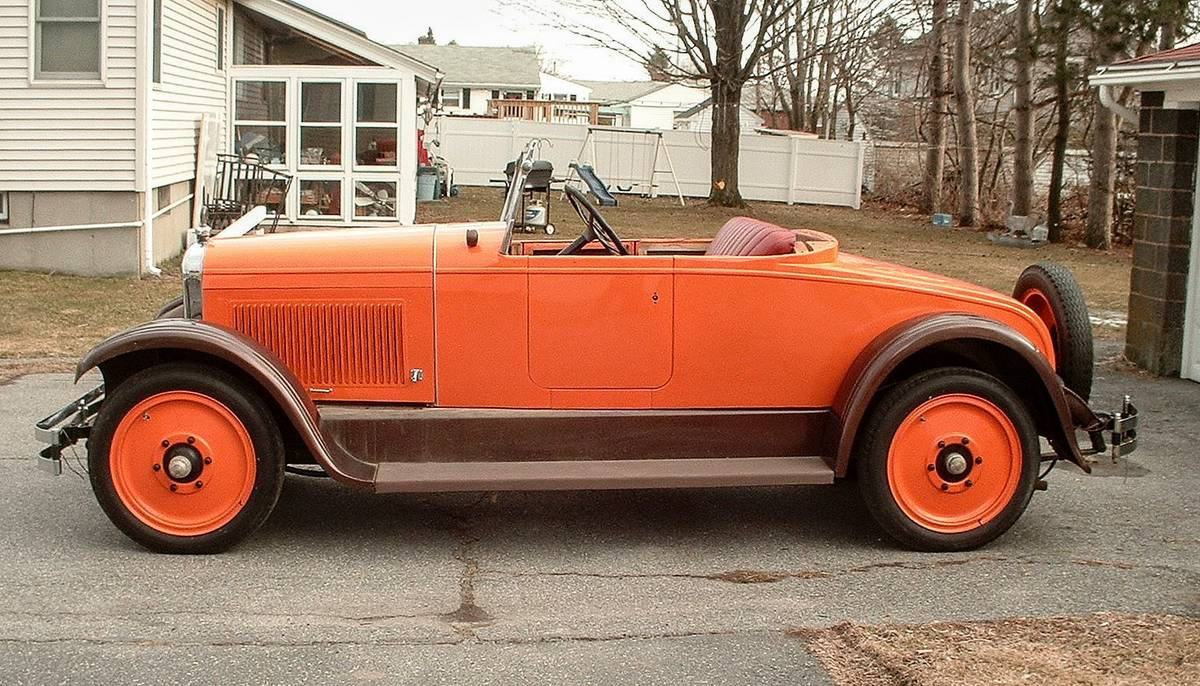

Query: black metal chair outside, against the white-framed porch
left=202, top=155, right=292, bottom=234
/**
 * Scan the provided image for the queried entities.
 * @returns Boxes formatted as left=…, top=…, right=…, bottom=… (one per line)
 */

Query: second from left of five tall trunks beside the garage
left=954, top=0, right=979, bottom=227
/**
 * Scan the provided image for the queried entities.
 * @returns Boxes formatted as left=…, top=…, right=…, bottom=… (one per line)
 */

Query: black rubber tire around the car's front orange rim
left=88, top=363, right=284, bottom=554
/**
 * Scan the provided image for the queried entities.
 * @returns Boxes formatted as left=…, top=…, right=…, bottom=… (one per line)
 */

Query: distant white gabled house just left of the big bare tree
left=580, top=82, right=710, bottom=131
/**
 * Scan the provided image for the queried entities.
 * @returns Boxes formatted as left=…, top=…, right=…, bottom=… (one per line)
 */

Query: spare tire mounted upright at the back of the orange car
left=1013, top=261, right=1093, bottom=401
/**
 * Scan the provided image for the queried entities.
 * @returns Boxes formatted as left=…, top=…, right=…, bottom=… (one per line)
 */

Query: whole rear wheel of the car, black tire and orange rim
left=858, top=368, right=1040, bottom=552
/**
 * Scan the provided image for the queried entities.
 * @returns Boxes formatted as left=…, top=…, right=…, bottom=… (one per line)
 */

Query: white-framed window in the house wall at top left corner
left=34, top=0, right=103, bottom=80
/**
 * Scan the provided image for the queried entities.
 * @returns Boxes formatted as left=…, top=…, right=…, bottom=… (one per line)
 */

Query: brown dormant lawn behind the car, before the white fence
left=418, top=188, right=1132, bottom=338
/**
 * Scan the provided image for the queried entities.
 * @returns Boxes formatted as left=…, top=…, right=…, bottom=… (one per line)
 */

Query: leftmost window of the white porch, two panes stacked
left=234, top=80, right=288, bottom=164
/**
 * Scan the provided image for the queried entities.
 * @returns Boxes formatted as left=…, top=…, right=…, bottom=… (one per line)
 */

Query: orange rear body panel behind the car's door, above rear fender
left=653, top=257, right=1049, bottom=408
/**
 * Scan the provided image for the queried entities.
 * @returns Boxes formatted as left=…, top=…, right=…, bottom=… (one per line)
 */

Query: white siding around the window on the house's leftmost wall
left=0, top=0, right=137, bottom=191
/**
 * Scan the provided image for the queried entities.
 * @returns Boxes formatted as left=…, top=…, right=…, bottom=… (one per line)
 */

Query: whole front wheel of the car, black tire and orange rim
left=88, top=365, right=284, bottom=553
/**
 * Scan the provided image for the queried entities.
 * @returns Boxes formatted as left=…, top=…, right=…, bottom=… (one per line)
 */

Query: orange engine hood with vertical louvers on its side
left=203, top=227, right=436, bottom=403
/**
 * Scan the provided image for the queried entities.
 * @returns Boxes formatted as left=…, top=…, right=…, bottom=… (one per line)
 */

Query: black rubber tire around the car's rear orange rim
left=857, top=367, right=1040, bottom=552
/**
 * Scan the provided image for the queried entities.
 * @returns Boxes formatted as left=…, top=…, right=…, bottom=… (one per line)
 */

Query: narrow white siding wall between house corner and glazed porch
left=150, top=0, right=229, bottom=187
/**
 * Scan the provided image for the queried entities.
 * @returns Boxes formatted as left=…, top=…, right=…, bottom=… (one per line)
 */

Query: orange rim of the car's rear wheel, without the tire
left=888, top=395, right=1024, bottom=534
